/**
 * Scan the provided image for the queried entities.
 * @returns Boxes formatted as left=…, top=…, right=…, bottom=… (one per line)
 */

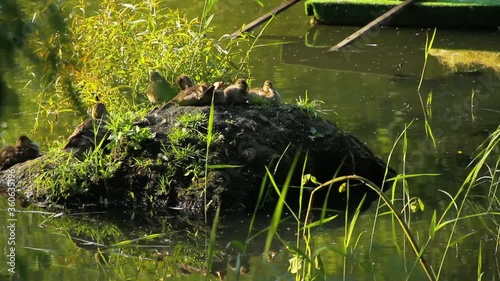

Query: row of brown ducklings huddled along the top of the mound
left=146, top=71, right=281, bottom=106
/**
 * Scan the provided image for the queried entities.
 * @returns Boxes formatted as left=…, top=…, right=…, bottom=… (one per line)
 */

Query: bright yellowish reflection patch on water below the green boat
left=429, top=49, right=500, bottom=72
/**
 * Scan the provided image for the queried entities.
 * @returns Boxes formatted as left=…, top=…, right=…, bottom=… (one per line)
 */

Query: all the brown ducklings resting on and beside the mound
left=0, top=71, right=281, bottom=170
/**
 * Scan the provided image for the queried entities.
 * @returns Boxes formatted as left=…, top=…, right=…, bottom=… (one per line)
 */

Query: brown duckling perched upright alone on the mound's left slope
left=63, top=95, right=108, bottom=153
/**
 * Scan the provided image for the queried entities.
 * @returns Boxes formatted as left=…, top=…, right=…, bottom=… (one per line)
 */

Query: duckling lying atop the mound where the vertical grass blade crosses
left=172, top=82, right=225, bottom=106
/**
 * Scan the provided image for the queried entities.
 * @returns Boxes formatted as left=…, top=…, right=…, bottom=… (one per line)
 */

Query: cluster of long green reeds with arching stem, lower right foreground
left=250, top=123, right=500, bottom=280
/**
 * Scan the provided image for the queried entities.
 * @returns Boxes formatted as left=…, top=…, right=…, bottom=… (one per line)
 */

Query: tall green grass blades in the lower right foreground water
left=254, top=123, right=500, bottom=280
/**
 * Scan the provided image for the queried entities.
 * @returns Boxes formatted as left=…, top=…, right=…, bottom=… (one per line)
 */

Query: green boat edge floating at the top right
left=305, top=0, right=500, bottom=29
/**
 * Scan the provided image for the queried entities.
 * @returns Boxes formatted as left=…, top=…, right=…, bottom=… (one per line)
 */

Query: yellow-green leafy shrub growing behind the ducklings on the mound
left=32, top=0, right=246, bottom=115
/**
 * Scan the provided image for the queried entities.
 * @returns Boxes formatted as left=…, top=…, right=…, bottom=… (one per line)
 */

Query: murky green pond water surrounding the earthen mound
left=0, top=0, right=500, bottom=280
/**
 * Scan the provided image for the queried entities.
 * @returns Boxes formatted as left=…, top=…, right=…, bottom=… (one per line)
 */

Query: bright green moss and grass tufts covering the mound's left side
left=28, top=106, right=228, bottom=204
